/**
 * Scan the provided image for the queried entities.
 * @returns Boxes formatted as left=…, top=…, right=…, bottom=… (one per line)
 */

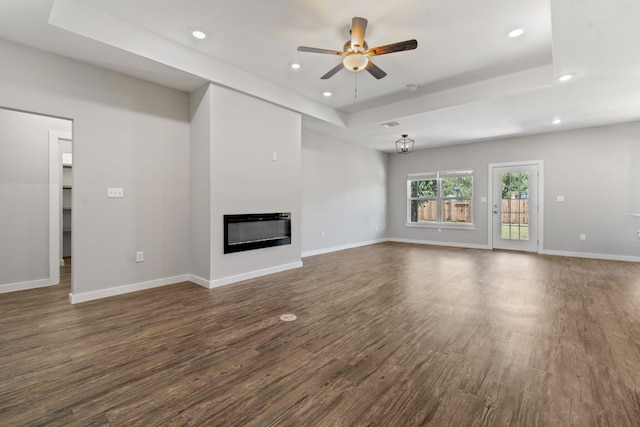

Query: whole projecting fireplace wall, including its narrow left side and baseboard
left=190, top=85, right=302, bottom=288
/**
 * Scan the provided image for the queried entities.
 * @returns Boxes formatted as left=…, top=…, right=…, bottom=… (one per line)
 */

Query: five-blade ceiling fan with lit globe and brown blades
left=298, top=17, right=418, bottom=80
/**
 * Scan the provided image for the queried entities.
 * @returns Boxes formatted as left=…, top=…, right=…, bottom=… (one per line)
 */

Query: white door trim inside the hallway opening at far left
left=49, top=130, right=71, bottom=285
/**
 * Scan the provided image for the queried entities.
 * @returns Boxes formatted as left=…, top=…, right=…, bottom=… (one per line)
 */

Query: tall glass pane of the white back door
left=500, top=172, right=529, bottom=240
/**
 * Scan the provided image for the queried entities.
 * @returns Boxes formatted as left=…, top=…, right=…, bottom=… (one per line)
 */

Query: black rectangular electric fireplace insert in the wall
left=224, top=212, right=291, bottom=254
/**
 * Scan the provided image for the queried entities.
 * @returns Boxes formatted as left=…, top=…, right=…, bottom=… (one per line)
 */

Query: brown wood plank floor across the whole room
left=0, top=243, right=640, bottom=426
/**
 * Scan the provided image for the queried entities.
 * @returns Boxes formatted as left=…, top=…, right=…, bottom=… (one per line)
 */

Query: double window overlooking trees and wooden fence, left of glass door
left=407, top=171, right=473, bottom=226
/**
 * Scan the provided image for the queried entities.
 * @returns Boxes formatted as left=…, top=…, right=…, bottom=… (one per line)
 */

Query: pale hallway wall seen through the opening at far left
left=0, top=108, right=72, bottom=288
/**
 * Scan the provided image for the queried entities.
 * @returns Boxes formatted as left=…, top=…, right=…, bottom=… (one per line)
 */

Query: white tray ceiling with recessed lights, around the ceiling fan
left=0, top=0, right=640, bottom=151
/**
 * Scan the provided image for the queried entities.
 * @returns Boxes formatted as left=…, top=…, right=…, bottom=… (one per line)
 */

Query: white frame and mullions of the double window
left=405, top=169, right=476, bottom=230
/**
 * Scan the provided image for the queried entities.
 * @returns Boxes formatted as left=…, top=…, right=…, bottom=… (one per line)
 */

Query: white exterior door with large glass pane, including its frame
left=489, top=160, right=543, bottom=252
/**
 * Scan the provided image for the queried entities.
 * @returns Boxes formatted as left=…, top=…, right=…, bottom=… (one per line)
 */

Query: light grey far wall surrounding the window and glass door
left=389, top=122, right=640, bottom=259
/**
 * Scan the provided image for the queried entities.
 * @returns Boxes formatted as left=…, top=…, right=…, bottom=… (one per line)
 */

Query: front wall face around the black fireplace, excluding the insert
left=209, top=85, right=302, bottom=283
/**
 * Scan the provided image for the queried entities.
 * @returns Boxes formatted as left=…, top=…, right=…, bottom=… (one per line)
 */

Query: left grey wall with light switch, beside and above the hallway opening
left=0, top=40, right=189, bottom=301
